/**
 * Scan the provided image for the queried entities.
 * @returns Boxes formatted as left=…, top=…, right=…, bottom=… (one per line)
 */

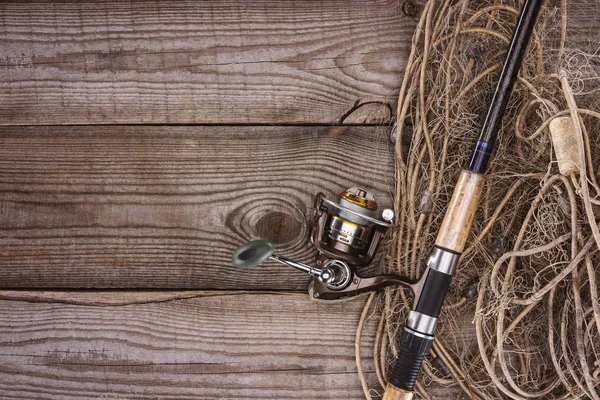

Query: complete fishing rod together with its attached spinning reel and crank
left=231, top=0, right=543, bottom=400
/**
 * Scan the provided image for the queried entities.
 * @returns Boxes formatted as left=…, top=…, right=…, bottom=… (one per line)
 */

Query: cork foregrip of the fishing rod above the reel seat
left=435, top=170, right=484, bottom=253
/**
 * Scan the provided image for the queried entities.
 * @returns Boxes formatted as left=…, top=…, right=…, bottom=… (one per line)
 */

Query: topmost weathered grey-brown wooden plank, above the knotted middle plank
left=0, top=0, right=418, bottom=124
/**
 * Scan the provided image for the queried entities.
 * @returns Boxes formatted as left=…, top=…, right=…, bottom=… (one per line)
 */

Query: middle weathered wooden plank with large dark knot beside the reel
left=0, top=126, right=394, bottom=290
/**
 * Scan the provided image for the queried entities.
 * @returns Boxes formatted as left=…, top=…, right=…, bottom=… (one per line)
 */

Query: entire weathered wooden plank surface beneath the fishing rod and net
left=0, top=0, right=599, bottom=399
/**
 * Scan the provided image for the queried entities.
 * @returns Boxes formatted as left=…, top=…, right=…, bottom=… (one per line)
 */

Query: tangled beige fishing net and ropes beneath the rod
left=357, top=0, right=600, bottom=400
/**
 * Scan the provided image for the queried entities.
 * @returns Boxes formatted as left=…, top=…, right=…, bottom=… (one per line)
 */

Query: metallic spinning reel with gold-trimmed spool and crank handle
left=232, top=188, right=411, bottom=300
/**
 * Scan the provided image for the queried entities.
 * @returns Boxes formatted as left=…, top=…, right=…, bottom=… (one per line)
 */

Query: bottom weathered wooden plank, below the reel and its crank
left=0, top=292, right=377, bottom=400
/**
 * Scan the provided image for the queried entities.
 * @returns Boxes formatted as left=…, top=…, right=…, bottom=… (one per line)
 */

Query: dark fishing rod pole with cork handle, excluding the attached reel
left=383, top=0, right=543, bottom=400
